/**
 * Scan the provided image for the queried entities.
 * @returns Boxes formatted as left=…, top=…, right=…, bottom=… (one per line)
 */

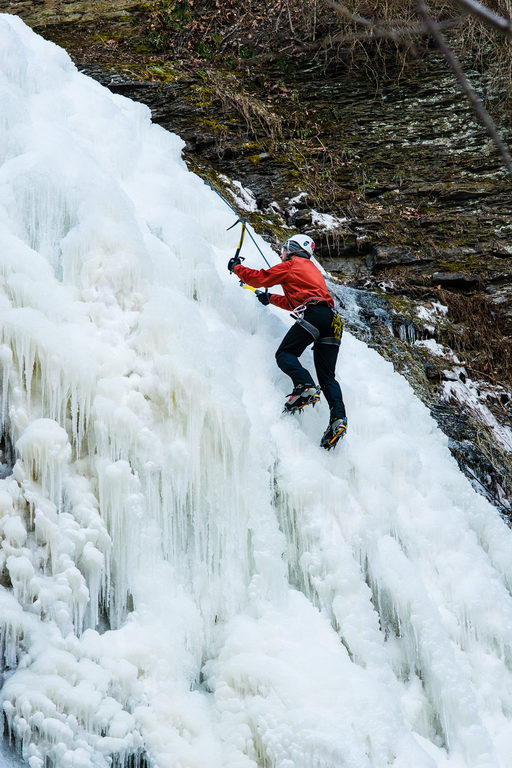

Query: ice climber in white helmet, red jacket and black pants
left=228, top=235, right=347, bottom=450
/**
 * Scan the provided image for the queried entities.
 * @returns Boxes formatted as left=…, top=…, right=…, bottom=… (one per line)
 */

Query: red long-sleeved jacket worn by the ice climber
left=233, top=256, right=334, bottom=311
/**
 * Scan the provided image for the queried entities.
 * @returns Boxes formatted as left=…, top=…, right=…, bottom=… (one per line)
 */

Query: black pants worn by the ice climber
left=276, top=304, right=346, bottom=419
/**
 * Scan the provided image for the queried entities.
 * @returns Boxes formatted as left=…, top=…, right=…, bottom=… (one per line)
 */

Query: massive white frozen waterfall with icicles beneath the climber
left=0, top=14, right=512, bottom=768
